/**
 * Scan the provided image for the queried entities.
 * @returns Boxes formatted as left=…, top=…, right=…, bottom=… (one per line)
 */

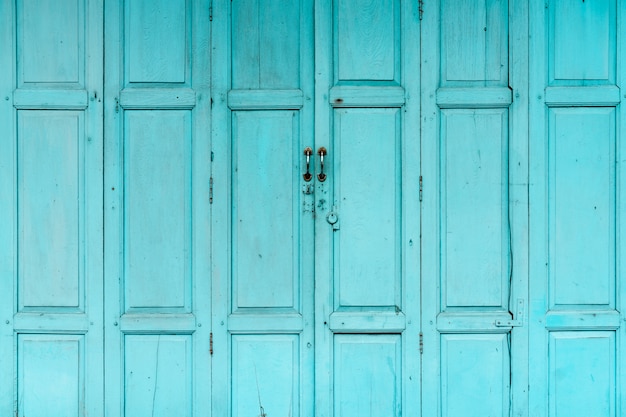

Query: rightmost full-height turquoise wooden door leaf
left=529, top=0, right=626, bottom=416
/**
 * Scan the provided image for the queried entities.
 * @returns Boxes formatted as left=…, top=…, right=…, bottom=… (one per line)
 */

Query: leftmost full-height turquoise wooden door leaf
left=0, top=0, right=103, bottom=416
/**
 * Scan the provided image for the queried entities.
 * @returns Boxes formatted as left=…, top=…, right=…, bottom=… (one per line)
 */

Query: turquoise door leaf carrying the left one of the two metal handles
left=212, top=0, right=314, bottom=417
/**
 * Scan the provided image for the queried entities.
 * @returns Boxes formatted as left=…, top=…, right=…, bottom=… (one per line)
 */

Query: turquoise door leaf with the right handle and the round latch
left=315, top=0, right=420, bottom=416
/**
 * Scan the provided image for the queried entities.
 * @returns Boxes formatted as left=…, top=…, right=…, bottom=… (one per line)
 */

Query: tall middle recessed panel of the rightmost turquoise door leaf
left=548, top=107, right=616, bottom=305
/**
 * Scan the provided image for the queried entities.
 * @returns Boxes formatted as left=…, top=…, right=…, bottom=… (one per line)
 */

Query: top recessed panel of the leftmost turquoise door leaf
left=17, top=0, right=85, bottom=84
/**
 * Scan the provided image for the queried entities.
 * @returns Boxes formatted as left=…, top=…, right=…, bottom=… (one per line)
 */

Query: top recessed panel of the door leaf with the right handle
left=334, top=0, right=400, bottom=81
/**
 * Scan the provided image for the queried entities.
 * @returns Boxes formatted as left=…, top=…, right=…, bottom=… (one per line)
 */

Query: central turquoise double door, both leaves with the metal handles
left=212, top=1, right=420, bottom=416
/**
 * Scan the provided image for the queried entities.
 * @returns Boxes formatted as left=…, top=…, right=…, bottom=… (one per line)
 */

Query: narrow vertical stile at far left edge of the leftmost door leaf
left=0, top=0, right=17, bottom=416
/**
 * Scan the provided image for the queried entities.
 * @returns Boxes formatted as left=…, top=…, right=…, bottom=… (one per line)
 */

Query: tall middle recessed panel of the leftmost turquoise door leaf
left=17, top=110, right=85, bottom=308
